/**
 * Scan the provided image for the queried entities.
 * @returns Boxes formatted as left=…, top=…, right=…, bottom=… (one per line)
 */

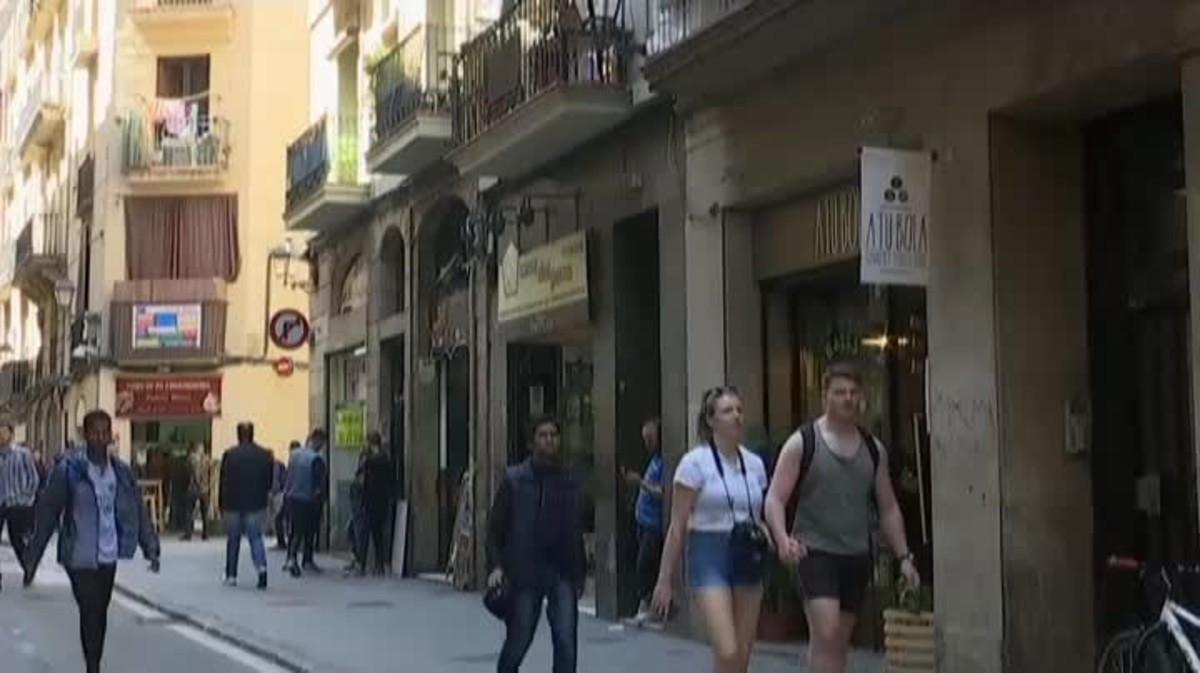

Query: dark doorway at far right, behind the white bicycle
left=1084, top=98, right=1200, bottom=643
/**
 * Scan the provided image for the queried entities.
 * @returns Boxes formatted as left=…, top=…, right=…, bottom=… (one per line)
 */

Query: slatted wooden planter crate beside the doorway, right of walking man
left=882, top=579, right=935, bottom=673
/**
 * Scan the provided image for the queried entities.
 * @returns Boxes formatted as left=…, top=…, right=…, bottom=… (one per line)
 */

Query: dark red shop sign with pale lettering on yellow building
left=116, top=377, right=221, bottom=417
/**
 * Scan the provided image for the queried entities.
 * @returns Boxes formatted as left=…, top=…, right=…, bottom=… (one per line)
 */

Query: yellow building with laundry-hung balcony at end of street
left=0, top=0, right=310, bottom=476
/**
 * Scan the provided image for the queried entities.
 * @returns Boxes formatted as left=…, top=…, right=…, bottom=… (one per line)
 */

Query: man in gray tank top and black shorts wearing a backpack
left=766, top=363, right=920, bottom=673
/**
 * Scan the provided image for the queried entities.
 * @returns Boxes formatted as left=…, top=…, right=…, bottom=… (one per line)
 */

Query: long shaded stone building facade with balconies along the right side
left=286, top=0, right=1200, bottom=672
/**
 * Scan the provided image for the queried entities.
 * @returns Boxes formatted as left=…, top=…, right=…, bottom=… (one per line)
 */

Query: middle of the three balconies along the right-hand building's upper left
left=367, top=25, right=466, bottom=175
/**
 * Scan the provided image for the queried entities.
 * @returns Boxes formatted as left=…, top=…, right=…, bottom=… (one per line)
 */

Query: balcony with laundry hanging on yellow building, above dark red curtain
left=121, top=106, right=229, bottom=184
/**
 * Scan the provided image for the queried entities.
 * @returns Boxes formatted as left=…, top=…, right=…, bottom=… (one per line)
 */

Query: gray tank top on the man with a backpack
left=792, top=427, right=875, bottom=557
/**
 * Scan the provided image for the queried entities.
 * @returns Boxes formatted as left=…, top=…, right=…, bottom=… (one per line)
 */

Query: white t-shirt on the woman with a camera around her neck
left=674, top=445, right=768, bottom=533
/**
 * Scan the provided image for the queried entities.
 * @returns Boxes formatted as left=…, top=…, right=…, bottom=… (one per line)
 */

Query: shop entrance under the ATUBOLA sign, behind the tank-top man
left=764, top=262, right=932, bottom=648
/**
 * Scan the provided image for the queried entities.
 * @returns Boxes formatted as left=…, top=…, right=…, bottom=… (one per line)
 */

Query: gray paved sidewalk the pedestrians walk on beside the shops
left=116, top=541, right=882, bottom=673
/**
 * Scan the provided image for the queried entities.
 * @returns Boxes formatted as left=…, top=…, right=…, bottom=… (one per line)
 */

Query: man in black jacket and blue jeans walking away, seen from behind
left=221, top=422, right=275, bottom=589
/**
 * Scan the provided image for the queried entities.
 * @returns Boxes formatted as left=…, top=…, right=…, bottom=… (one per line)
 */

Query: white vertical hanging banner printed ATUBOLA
left=860, top=148, right=934, bottom=286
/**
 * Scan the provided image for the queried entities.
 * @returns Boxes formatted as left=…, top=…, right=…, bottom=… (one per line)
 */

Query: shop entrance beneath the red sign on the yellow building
left=131, top=419, right=218, bottom=534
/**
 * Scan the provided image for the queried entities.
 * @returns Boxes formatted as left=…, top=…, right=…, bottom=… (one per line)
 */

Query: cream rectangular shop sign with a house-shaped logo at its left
left=498, top=232, right=588, bottom=323
